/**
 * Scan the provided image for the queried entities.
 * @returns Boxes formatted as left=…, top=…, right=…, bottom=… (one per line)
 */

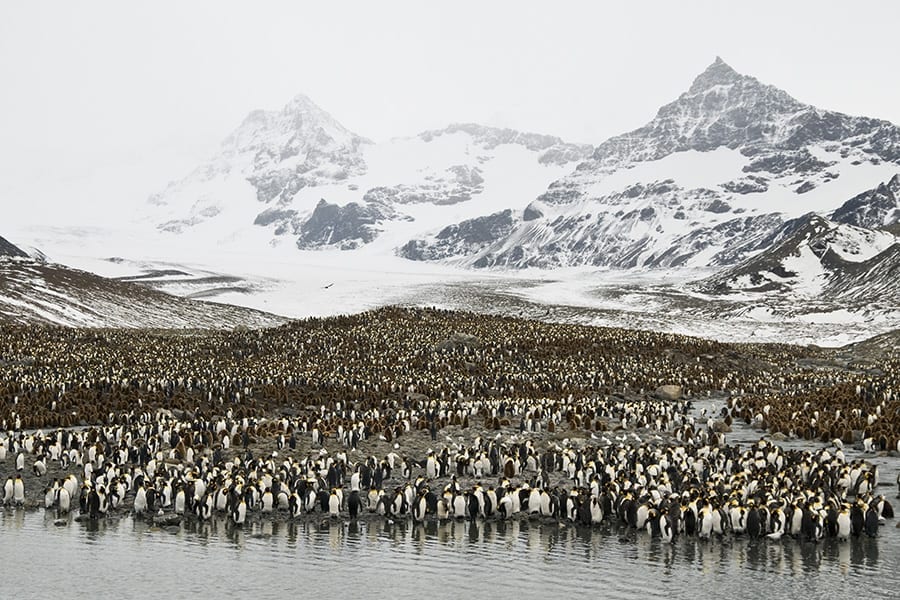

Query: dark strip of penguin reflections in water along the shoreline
left=0, top=509, right=884, bottom=576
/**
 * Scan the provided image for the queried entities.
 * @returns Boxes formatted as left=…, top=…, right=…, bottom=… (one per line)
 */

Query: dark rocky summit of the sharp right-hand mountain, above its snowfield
left=580, top=58, right=900, bottom=174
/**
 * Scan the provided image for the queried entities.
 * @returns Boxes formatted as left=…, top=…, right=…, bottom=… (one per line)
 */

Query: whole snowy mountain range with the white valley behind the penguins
left=29, top=59, right=900, bottom=341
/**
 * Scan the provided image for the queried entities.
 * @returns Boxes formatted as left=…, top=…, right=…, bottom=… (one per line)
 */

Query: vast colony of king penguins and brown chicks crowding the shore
left=0, top=308, right=900, bottom=540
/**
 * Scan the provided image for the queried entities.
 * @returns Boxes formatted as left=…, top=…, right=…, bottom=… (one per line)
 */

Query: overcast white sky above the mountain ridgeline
left=0, top=0, right=900, bottom=226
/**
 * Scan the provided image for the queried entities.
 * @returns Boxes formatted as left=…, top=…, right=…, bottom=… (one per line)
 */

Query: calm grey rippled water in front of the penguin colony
left=0, top=400, right=900, bottom=600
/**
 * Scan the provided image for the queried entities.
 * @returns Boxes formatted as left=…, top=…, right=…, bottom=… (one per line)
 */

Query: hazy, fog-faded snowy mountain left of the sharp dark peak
left=148, top=96, right=592, bottom=254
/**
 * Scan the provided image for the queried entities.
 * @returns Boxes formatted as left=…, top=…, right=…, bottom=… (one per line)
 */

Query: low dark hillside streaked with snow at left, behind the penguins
left=0, top=255, right=286, bottom=329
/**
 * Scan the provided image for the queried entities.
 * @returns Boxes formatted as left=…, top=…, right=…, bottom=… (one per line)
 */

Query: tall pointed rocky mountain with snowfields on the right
left=401, top=58, right=900, bottom=268
